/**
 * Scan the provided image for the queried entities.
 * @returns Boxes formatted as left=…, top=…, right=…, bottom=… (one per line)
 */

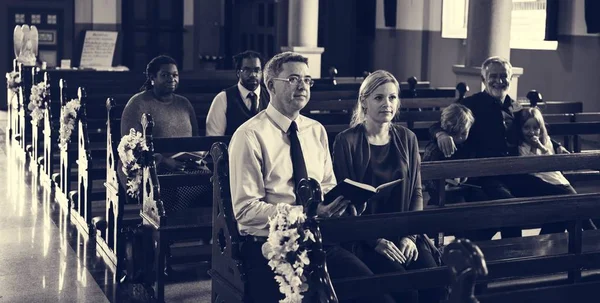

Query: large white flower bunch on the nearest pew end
left=262, top=203, right=316, bottom=303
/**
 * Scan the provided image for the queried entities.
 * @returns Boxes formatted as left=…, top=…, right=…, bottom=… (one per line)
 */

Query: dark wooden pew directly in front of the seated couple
left=320, top=194, right=600, bottom=299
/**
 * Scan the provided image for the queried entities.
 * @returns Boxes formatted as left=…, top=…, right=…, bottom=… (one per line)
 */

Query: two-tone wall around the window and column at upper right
left=373, top=0, right=600, bottom=111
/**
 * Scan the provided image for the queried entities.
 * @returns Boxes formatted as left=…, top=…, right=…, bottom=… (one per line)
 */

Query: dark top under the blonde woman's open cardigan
left=365, top=143, right=410, bottom=214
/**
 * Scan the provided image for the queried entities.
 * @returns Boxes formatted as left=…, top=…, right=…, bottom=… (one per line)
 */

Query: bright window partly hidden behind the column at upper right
left=442, top=0, right=558, bottom=50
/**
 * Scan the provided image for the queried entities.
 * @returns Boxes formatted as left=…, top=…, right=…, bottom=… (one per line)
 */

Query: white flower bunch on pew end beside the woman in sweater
left=117, top=128, right=148, bottom=198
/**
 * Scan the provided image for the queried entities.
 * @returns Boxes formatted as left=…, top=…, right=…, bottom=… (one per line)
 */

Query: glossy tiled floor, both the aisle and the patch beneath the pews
left=0, top=111, right=210, bottom=303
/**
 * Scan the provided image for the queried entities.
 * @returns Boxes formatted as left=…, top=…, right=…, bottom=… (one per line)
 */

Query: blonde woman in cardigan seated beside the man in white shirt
left=333, top=70, right=442, bottom=302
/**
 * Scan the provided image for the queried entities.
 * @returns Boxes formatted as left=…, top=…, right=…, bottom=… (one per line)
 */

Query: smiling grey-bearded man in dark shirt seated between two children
left=429, top=57, right=567, bottom=237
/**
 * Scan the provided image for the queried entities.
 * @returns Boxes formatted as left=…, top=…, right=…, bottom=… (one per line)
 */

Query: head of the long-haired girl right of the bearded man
left=515, top=107, right=550, bottom=145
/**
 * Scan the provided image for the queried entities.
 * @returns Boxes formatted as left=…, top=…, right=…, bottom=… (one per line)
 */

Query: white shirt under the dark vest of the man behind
left=206, top=82, right=260, bottom=136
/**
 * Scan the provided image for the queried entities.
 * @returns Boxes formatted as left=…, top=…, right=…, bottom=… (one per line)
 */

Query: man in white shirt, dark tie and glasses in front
left=229, top=52, right=393, bottom=302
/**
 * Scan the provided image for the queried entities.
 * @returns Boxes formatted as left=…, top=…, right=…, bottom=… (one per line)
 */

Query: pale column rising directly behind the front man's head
left=281, top=0, right=325, bottom=79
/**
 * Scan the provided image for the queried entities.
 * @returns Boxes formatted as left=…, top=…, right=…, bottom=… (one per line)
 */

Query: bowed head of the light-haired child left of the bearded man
left=441, top=103, right=475, bottom=144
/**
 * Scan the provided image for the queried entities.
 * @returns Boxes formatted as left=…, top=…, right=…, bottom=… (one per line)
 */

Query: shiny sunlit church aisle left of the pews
left=0, top=111, right=108, bottom=303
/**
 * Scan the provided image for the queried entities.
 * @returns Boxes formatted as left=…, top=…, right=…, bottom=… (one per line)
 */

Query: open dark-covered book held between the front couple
left=324, top=179, right=404, bottom=206
